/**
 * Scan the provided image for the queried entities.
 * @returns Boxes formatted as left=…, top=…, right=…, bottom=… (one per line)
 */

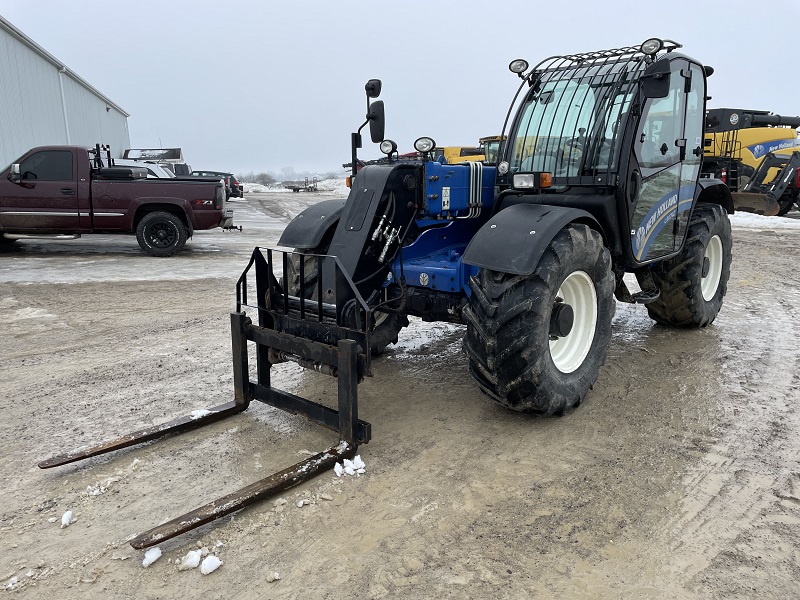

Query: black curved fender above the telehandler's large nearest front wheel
left=462, top=204, right=600, bottom=275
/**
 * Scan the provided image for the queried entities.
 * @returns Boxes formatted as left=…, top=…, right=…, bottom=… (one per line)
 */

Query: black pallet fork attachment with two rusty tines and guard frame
left=39, top=248, right=374, bottom=548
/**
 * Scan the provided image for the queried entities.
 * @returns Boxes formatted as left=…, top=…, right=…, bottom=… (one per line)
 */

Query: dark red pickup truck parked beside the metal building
left=0, top=146, right=233, bottom=256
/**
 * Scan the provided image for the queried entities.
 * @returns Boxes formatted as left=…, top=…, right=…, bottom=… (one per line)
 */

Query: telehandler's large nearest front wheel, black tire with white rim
left=464, top=224, right=615, bottom=415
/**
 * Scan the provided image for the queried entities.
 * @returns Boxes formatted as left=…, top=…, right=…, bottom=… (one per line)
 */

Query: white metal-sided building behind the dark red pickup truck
left=0, top=16, right=131, bottom=169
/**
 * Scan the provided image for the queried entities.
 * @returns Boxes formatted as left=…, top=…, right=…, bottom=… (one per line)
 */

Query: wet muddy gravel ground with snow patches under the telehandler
left=0, top=193, right=800, bottom=600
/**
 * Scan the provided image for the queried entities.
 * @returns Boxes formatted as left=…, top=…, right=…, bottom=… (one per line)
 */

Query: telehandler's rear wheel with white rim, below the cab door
left=637, top=204, right=733, bottom=327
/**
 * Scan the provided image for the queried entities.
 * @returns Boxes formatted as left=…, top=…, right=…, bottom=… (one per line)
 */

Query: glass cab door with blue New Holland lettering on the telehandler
left=630, top=58, right=705, bottom=262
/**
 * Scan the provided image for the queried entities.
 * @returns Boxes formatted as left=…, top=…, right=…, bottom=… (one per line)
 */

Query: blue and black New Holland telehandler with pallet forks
left=40, top=39, right=733, bottom=548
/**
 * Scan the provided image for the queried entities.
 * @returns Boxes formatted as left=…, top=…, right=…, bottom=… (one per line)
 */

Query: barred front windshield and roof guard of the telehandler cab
left=502, top=39, right=680, bottom=186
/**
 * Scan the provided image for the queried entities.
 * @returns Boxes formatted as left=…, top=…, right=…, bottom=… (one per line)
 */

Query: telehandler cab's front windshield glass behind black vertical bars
left=509, top=64, right=636, bottom=177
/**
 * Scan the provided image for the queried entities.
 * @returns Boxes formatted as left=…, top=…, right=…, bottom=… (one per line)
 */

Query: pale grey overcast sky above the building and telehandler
left=0, top=0, right=800, bottom=174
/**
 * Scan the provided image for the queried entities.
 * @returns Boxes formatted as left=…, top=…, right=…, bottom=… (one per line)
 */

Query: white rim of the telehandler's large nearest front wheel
left=550, top=271, right=597, bottom=373
